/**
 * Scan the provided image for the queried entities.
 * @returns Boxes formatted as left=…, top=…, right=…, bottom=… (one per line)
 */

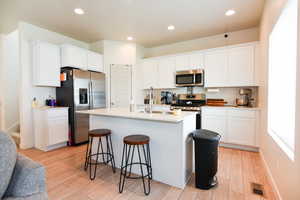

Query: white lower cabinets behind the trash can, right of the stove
left=202, top=107, right=259, bottom=147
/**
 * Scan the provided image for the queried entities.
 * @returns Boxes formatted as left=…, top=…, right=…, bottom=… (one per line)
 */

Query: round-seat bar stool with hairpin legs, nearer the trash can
left=119, top=135, right=152, bottom=195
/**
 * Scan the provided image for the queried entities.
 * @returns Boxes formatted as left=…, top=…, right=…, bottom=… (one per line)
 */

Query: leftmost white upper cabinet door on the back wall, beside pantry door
left=142, top=60, right=159, bottom=89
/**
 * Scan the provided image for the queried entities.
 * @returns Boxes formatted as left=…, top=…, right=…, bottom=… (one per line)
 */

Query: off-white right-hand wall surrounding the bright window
left=259, top=0, right=300, bottom=200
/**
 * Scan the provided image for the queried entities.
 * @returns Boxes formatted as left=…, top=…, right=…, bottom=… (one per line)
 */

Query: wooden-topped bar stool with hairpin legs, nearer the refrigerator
left=84, top=129, right=116, bottom=180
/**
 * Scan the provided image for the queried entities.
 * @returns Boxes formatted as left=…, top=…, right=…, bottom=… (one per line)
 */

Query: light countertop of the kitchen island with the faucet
left=77, top=108, right=196, bottom=123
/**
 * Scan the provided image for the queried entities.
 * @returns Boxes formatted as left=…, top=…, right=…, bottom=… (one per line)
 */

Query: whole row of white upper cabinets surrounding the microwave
left=140, top=43, right=260, bottom=88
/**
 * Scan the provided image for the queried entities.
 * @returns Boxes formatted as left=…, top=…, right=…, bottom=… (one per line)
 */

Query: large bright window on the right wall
left=268, top=0, right=298, bottom=160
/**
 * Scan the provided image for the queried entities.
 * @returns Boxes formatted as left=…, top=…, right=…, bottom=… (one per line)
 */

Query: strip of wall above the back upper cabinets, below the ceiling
left=145, top=27, right=259, bottom=58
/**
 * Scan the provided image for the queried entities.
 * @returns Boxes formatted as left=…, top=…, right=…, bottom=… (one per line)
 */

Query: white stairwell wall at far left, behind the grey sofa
left=1, top=31, right=20, bottom=132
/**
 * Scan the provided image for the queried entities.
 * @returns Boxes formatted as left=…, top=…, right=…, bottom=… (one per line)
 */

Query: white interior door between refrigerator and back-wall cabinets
left=110, top=65, right=132, bottom=108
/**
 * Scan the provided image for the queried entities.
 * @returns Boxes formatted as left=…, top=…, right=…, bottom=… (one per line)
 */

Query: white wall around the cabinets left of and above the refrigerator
left=18, top=22, right=89, bottom=148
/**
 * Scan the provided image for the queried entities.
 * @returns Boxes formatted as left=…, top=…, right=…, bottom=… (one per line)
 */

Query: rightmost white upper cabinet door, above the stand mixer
left=228, top=45, right=254, bottom=86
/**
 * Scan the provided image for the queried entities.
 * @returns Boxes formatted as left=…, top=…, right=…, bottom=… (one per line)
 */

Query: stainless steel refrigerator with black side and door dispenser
left=56, top=67, right=106, bottom=145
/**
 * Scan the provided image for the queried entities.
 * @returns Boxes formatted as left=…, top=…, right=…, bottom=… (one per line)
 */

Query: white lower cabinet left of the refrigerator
left=33, top=107, right=69, bottom=151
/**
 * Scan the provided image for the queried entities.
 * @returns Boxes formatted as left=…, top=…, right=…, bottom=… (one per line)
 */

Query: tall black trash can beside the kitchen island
left=193, top=129, right=221, bottom=190
